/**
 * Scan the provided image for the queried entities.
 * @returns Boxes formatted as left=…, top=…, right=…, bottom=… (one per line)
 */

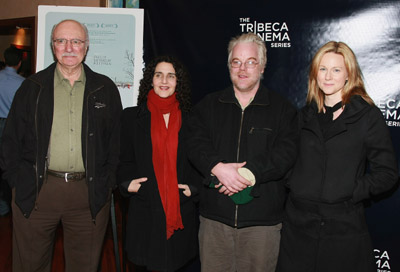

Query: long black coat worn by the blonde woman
left=277, top=96, right=398, bottom=272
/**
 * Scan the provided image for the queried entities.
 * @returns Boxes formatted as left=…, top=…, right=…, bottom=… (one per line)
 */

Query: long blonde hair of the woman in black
left=307, top=41, right=374, bottom=112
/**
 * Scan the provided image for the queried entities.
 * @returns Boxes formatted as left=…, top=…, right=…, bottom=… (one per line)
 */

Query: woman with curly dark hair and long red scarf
left=118, top=56, right=198, bottom=271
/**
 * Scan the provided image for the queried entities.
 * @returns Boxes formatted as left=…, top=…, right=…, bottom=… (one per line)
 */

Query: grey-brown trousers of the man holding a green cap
left=199, top=216, right=282, bottom=272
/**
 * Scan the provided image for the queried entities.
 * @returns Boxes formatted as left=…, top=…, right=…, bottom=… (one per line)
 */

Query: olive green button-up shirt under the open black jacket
left=48, top=67, right=86, bottom=172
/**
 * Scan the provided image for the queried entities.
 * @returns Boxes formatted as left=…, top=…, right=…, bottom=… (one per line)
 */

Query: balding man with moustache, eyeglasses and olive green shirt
left=0, top=20, right=122, bottom=272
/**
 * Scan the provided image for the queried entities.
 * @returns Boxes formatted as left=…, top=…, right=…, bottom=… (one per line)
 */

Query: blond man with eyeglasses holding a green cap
left=187, top=33, right=297, bottom=272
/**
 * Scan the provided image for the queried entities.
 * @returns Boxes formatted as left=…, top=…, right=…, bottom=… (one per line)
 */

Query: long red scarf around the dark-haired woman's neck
left=147, top=89, right=183, bottom=239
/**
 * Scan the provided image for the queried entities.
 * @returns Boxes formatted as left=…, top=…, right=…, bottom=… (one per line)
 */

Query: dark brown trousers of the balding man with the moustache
left=12, top=176, right=110, bottom=272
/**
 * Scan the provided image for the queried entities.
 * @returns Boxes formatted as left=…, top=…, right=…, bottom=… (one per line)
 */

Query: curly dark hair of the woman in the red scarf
left=137, top=56, right=192, bottom=112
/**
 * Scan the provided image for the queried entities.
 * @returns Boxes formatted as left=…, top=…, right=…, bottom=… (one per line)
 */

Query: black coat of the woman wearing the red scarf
left=117, top=106, right=198, bottom=271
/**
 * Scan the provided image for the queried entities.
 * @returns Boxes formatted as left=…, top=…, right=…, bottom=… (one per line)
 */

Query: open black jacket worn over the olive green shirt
left=1, top=63, right=122, bottom=219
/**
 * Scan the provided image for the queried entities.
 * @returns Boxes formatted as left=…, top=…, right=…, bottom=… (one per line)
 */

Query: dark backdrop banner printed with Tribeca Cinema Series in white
left=141, top=0, right=400, bottom=272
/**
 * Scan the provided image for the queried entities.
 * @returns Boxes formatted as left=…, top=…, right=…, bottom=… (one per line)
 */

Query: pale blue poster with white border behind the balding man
left=36, top=5, right=143, bottom=108
